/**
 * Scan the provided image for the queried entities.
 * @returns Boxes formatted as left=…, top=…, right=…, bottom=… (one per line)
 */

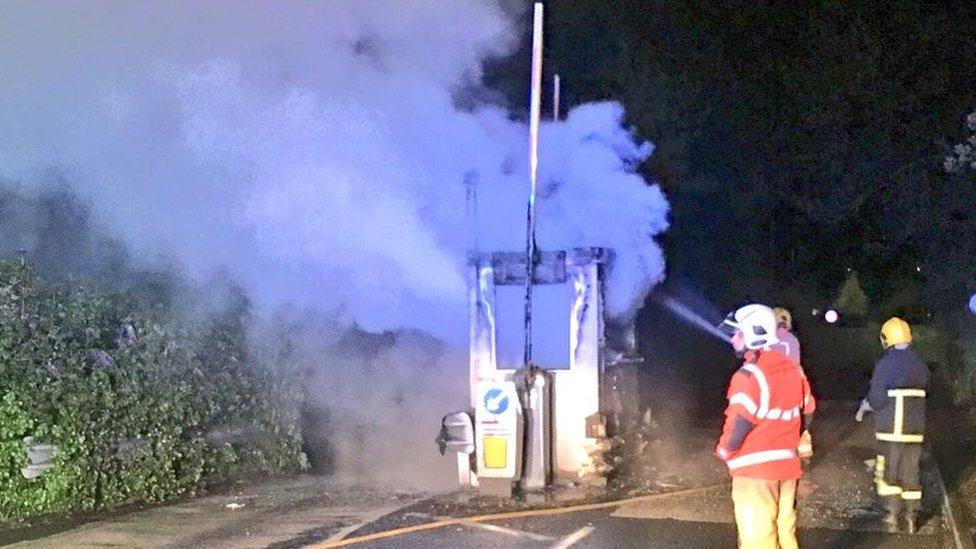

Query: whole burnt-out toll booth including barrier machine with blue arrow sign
left=441, top=248, right=641, bottom=495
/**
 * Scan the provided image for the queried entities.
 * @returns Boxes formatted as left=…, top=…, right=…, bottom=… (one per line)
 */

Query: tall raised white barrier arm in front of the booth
left=523, top=2, right=542, bottom=368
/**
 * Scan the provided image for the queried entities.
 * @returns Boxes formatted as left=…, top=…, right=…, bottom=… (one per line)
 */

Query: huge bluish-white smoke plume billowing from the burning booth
left=0, top=0, right=668, bottom=488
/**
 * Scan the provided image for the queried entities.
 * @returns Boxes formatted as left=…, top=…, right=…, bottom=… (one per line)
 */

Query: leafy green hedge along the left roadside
left=0, top=261, right=306, bottom=518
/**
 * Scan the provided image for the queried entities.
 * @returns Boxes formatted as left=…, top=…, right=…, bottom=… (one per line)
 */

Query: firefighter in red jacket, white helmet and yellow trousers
left=715, top=304, right=814, bottom=549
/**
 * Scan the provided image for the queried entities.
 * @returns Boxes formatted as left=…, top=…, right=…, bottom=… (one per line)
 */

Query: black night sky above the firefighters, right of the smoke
left=488, top=0, right=976, bottom=316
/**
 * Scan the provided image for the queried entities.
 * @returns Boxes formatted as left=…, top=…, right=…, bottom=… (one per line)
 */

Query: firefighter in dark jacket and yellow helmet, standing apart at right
left=855, top=318, right=929, bottom=533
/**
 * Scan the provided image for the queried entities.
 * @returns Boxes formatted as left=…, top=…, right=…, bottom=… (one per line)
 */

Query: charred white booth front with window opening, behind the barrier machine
left=460, top=248, right=622, bottom=483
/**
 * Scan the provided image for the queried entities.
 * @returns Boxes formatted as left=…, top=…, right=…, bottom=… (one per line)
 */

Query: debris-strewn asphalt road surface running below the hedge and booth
left=9, top=405, right=946, bottom=549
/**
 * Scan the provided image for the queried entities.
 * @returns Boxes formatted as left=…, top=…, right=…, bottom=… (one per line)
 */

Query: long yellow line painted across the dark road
left=307, top=482, right=729, bottom=549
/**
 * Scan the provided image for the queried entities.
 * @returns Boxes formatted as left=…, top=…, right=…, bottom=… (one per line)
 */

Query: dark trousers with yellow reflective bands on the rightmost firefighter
left=874, top=441, right=922, bottom=512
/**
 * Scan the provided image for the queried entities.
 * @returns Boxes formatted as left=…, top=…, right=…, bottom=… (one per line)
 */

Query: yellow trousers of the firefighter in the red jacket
left=732, top=477, right=798, bottom=549
